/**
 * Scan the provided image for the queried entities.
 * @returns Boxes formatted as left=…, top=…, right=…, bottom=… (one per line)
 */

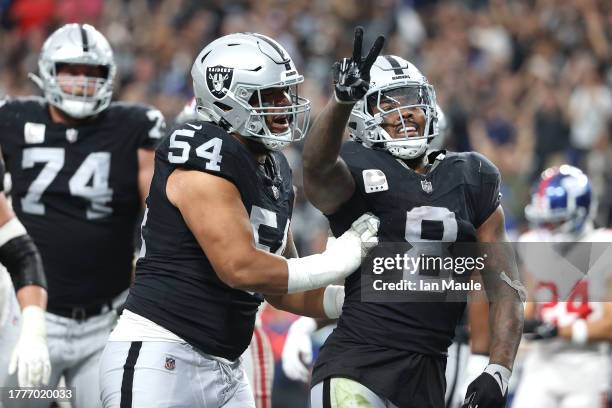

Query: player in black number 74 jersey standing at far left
left=0, top=24, right=165, bottom=407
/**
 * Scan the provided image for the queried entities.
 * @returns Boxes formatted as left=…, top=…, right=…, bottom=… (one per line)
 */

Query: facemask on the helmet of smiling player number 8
left=363, top=83, right=438, bottom=159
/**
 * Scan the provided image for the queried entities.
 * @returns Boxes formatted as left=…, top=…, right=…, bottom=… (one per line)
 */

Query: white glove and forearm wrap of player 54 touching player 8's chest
left=287, top=213, right=380, bottom=293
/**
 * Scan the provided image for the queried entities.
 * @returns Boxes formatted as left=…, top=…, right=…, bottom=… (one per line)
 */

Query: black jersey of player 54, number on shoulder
left=126, top=122, right=294, bottom=360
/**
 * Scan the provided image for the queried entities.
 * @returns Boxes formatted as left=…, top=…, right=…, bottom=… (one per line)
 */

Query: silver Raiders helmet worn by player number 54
left=191, top=33, right=310, bottom=150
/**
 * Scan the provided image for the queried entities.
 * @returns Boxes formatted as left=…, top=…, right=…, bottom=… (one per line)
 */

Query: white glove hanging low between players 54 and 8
left=282, top=317, right=317, bottom=383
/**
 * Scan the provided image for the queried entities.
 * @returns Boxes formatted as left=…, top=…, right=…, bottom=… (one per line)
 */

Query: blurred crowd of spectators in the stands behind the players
left=0, top=0, right=612, bottom=407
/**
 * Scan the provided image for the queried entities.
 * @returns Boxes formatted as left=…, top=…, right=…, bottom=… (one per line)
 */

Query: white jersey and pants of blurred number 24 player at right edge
left=512, top=229, right=612, bottom=408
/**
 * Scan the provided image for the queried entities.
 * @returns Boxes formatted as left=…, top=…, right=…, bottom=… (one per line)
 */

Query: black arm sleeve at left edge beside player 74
left=0, top=234, right=47, bottom=291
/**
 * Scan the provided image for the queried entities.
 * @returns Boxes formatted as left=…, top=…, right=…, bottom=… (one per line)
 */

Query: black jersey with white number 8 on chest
left=312, top=141, right=500, bottom=407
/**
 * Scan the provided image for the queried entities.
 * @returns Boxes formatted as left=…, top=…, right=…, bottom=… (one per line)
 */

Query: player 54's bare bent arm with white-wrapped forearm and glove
left=166, top=169, right=379, bottom=294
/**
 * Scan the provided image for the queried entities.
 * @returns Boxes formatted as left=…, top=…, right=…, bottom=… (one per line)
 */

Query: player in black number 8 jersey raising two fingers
left=304, top=28, right=522, bottom=408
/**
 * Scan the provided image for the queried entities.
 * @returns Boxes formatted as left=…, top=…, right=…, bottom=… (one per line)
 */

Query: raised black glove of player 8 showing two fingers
left=332, top=27, right=385, bottom=103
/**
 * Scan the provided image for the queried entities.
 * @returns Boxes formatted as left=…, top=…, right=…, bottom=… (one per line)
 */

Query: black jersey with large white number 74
left=0, top=97, right=164, bottom=310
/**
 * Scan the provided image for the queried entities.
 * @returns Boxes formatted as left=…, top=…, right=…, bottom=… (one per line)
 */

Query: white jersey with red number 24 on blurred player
left=519, top=229, right=612, bottom=358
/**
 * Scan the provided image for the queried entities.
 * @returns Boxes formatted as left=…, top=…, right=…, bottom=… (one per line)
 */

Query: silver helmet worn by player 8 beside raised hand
left=349, top=55, right=439, bottom=159
